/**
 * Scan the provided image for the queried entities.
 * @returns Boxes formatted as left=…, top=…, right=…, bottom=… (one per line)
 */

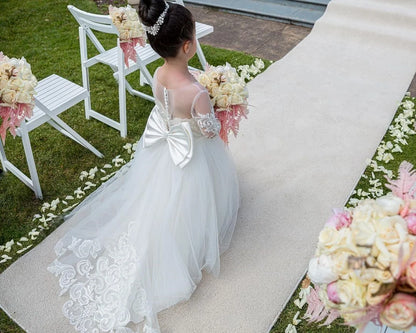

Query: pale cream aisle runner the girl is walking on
left=0, top=0, right=416, bottom=333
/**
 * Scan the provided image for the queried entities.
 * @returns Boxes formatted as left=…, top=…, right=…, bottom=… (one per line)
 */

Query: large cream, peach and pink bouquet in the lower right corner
left=307, top=162, right=416, bottom=330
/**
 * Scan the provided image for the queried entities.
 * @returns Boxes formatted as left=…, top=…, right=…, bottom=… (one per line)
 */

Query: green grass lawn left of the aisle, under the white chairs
left=0, top=0, right=270, bottom=333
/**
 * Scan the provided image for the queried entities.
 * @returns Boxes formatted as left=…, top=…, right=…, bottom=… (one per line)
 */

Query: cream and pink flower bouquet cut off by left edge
left=0, top=52, right=37, bottom=144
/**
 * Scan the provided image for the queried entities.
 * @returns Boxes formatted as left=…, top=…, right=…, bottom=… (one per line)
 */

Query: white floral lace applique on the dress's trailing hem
left=47, top=222, right=159, bottom=333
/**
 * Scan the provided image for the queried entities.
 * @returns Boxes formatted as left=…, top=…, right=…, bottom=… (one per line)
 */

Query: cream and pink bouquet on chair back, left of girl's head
left=108, top=5, right=146, bottom=67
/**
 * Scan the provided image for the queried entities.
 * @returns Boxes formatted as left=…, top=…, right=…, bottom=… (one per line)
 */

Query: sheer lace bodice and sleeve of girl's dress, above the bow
left=153, top=68, right=221, bottom=138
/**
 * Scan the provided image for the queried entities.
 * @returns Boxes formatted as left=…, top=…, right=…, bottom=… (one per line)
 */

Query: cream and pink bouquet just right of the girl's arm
left=196, top=63, right=248, bottom=144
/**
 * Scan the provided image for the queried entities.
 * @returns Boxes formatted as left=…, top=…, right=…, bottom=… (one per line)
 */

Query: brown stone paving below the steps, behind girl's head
left=186, top=4, right=416, bottom=96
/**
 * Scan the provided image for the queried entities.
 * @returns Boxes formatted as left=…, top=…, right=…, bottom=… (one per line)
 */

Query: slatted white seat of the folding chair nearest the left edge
left=22, top=74, right=88, bottom=134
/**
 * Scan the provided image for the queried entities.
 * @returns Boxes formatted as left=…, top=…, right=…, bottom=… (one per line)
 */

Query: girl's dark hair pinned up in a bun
left=139, top=0, right=195, bottom=58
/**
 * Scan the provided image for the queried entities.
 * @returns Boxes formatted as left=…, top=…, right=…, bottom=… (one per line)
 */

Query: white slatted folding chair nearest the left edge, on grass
left=0, top=74, right=103, bottom=199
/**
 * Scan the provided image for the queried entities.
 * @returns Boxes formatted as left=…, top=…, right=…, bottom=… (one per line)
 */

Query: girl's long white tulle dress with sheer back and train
left=47, top=67, right=240, bottom=333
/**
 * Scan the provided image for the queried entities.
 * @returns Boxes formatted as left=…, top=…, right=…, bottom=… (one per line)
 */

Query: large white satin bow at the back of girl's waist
left=143, top=107, right=193, bottom=168
